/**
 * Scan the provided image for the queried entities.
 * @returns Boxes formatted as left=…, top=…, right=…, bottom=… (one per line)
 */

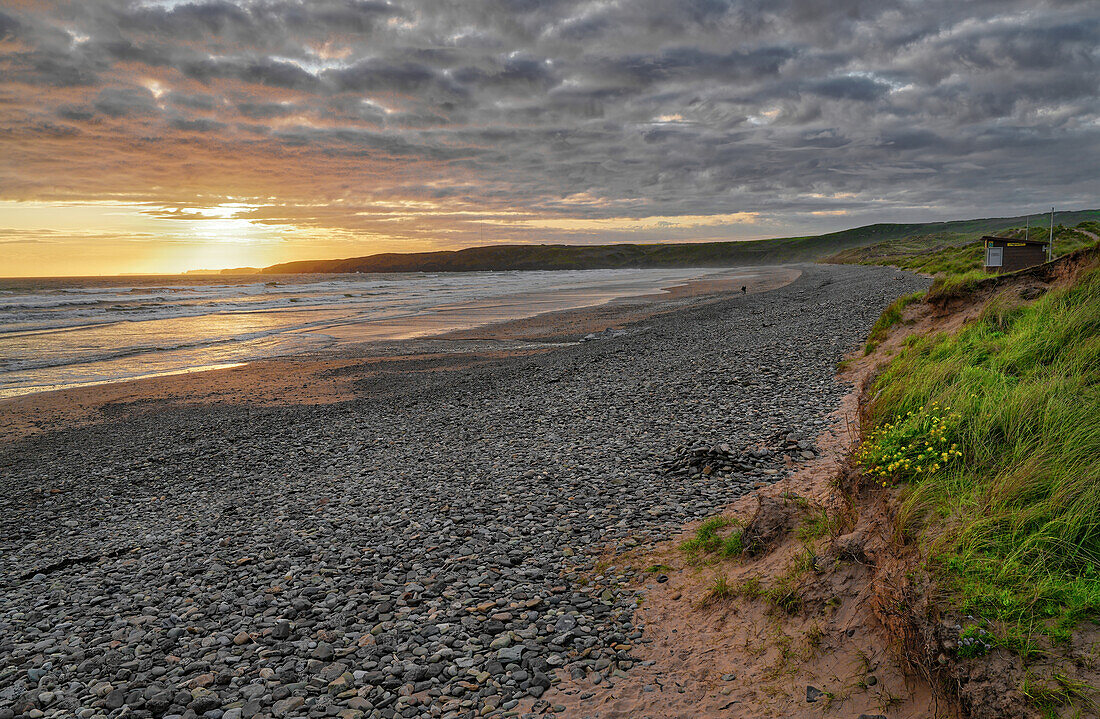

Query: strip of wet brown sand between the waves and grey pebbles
left=0, top=267, right=801, bottom=444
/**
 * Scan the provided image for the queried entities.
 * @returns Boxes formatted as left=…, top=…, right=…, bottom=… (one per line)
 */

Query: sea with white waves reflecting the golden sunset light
left=0, top=268, right=719, bottom=398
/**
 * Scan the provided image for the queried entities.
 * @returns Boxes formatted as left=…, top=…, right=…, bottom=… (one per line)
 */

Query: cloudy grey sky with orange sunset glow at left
left=0, top=0, right=1100, bottom=276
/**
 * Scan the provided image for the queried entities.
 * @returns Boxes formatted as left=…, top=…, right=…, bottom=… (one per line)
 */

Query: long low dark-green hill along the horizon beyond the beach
left=251, top=210, right=1100, bottom=275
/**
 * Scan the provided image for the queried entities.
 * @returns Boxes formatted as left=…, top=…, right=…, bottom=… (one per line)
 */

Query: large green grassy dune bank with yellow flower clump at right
left=860, top=269, right=1100, bottom=640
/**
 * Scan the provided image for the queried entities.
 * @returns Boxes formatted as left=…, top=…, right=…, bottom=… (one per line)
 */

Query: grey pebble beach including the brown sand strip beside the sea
left=0, top=265, right=925, bottom=719
